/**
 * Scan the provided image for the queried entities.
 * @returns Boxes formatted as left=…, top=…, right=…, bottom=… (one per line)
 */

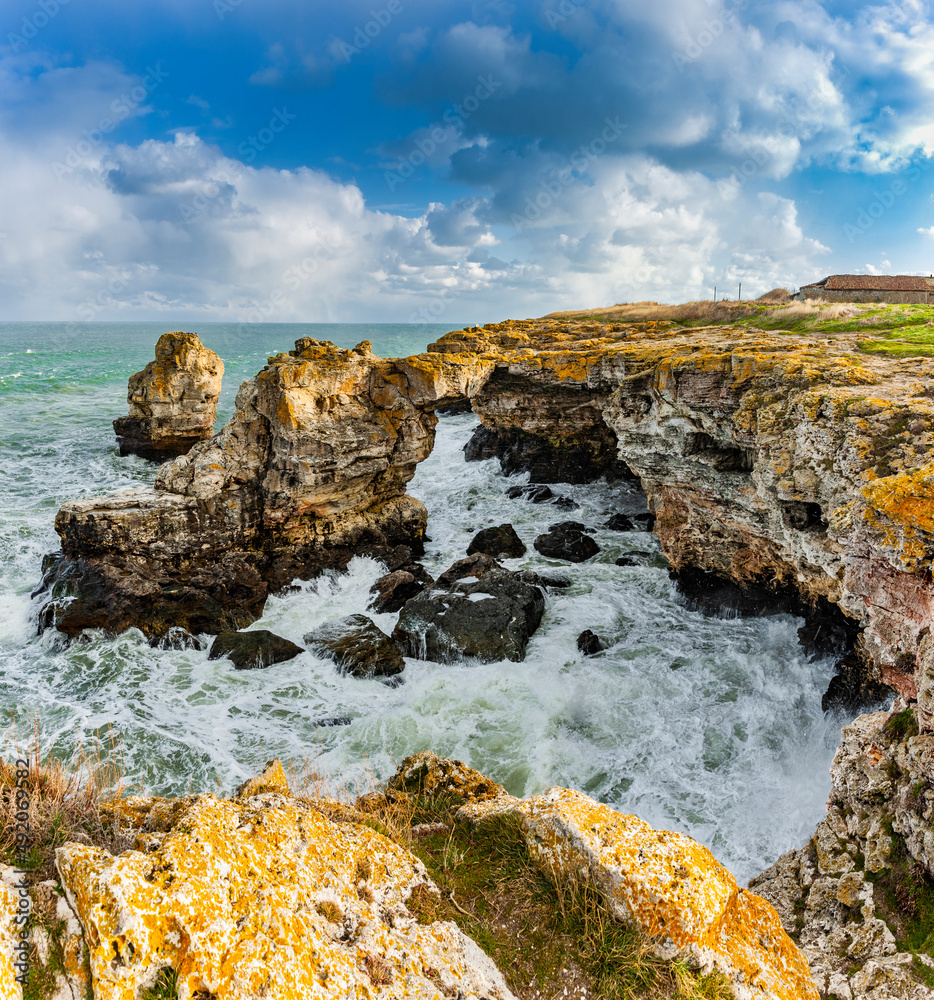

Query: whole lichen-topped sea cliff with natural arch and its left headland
left=44, top=320, right=934, bottom=727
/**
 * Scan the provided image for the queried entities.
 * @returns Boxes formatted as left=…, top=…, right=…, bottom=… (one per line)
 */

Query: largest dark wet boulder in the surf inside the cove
left=392, top=572, right=545, bottom=663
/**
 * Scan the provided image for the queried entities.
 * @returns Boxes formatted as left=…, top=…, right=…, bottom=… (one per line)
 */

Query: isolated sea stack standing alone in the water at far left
left=114, top=332, right=224, bottom=462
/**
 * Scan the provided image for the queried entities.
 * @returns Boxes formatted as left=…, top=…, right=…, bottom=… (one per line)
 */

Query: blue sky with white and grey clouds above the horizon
left=0, top=0, right=934, bottom=325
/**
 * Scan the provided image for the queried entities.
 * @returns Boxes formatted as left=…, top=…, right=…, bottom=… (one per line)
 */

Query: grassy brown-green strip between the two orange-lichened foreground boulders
left=356, top=794, right=732, bottom=1000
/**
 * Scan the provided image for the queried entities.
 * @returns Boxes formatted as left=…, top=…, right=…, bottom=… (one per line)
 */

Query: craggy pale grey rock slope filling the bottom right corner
left=750, top=708, right=934, bottom=1000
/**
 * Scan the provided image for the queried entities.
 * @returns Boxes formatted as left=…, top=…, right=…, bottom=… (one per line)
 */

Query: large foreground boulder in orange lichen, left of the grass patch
left=57, top=793, right=511, bottom=1000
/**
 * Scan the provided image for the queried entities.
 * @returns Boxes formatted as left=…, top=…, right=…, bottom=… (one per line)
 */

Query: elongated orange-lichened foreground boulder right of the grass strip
left=459, top=788, right=818, bottom=1000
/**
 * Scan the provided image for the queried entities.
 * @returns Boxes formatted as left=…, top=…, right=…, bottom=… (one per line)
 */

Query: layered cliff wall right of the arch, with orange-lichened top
left=430, top=320, right=934, bottom=727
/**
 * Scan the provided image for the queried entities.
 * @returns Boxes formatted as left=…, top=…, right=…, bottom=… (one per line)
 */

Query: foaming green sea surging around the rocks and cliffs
left=0, top=323, right=847, bottom=881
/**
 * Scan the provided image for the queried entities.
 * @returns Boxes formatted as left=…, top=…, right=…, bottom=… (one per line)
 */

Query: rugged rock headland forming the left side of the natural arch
left=43, top=338, right=483, bottom=635
